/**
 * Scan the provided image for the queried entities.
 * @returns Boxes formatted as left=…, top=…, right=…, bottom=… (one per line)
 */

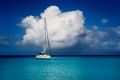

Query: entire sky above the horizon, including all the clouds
left=0, top=0, right=120, bottom=55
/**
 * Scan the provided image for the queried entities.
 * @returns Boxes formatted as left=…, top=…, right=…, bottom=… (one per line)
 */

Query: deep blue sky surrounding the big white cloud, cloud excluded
left=0, top=0, right=120, bottom=55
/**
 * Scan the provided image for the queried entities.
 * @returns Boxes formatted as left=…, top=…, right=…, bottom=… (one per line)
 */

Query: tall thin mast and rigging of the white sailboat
left=43, top=18, right=51, bottom=55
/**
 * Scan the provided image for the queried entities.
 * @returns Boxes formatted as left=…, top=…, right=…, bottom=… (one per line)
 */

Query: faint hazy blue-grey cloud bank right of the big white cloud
left=79, top=25, right=120, bottom=50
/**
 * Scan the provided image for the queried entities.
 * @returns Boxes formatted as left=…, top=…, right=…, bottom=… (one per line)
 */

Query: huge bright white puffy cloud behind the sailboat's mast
left=20, top=6, right=84, bottom=48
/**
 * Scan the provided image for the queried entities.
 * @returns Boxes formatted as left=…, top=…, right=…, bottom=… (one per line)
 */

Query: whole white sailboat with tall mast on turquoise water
left=35, top=18, right=51, bottom=59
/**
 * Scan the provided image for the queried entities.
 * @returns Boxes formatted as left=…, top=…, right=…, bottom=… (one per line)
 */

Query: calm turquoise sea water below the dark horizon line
left=0, top=57, right=120, bottom=80
